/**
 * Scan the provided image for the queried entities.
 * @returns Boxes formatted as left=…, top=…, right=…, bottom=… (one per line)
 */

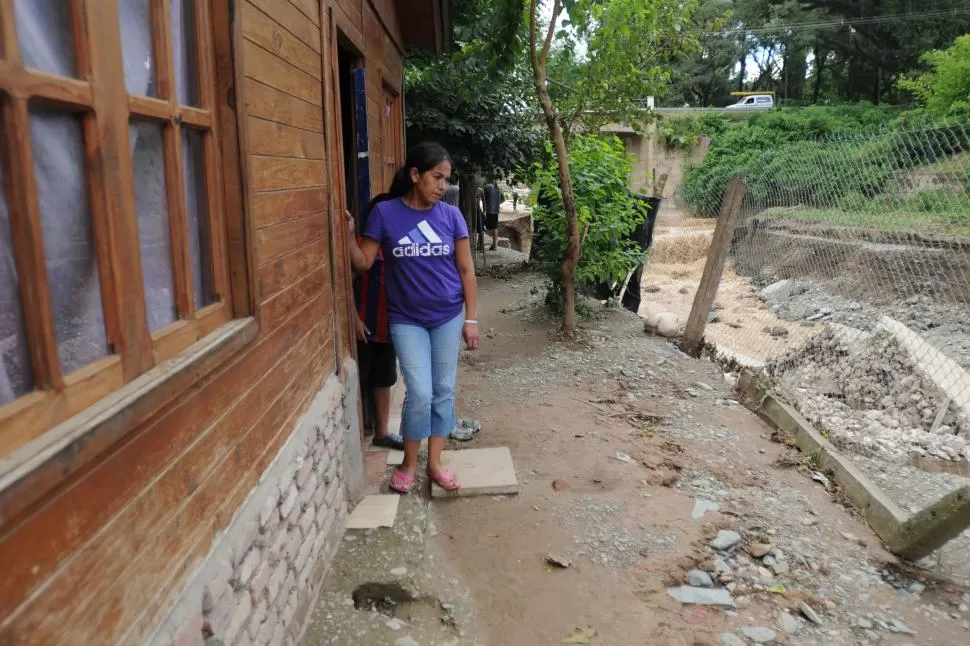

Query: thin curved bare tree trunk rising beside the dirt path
left=529, top=0, right=581, bottom=334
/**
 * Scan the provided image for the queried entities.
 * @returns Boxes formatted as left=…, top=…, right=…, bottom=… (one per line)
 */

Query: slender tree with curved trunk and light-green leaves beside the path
left=524, top=0, right=697, bottom=334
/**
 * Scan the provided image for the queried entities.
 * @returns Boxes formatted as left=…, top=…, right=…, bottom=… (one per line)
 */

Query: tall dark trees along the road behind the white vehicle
left=663, top=0, right=970, bottom=105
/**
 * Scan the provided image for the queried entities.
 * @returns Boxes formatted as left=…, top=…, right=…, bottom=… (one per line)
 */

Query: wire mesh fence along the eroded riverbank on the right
left=641, top=116, right=970, bottom=574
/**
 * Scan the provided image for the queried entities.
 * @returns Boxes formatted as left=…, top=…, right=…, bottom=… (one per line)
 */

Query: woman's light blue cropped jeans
left=391, top=313, right=465, bottom=442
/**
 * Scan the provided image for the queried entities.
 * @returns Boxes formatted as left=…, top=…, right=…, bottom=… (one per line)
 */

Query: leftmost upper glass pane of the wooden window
left=13, top=0, right=77, bottom=76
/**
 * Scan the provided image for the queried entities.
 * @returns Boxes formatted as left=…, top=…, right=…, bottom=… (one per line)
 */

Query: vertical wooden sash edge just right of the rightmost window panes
left=196, top=2, right=230, bottom=314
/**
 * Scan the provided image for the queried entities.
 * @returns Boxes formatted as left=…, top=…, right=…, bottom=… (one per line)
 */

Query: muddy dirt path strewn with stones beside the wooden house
left=304, top=276, right=970, bottom=646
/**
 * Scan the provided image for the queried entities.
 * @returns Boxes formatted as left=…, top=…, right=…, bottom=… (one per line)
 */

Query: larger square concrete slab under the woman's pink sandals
left=431, top=446, right=519, bottom=498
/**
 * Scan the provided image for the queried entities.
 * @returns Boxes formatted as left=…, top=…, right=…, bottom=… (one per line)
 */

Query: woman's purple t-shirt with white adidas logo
left=364, top=199, right=468, bottom=328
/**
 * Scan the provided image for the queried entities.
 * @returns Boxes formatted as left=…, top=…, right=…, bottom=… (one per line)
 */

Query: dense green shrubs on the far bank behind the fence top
left=681, top=104, right=970, bottom=217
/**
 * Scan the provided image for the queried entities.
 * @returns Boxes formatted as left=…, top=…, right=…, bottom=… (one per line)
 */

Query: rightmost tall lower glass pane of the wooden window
left=182, top=128, right=219, bottom=308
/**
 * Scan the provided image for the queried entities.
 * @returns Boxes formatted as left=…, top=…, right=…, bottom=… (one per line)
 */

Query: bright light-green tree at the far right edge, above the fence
left=899, top=35, right=970, bottom=116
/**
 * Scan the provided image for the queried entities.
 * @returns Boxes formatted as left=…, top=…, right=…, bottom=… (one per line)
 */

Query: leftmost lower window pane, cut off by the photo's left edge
left=0, top=124, right=34, bottom=406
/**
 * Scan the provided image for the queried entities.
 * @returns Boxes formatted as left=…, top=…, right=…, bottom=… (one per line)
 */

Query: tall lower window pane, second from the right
left=129, top=121, right=178, bottom=332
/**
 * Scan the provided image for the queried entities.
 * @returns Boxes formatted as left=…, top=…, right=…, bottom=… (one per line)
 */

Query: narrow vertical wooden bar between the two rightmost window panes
left=152, top=0, right=195, bottom=319
